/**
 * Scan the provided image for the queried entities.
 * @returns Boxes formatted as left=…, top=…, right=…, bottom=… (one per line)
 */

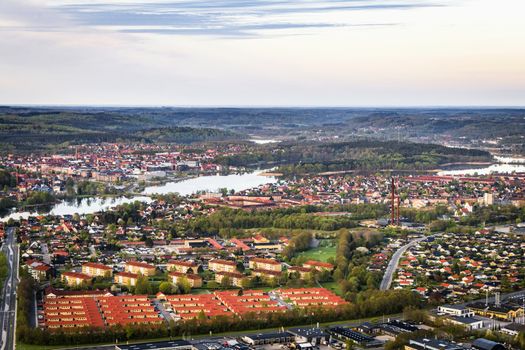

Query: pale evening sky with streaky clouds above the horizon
left=0, top=0, right=525, bottom=107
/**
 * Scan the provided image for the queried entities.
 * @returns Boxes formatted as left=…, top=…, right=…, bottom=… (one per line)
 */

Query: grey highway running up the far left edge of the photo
left=0, top=227, right=19, bottom=350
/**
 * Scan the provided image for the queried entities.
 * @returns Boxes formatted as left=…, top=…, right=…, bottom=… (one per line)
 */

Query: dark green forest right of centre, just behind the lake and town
left=216, top=139, right=492, bottom=175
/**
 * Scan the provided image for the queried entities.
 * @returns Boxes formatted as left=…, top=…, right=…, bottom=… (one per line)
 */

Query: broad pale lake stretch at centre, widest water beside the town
left=142, top=170, right=277, bottom=196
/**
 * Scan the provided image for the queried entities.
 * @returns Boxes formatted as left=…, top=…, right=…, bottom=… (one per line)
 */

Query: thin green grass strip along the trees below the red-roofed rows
left=16, top=314, right=401, bottom=350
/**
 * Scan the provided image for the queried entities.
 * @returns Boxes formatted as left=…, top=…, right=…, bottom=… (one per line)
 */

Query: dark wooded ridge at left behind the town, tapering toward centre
left=0, top=108, right=242, bottom=152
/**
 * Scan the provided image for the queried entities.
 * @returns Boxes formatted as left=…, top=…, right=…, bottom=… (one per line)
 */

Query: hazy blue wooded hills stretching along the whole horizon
left=0, top=106, right=525, bottom=154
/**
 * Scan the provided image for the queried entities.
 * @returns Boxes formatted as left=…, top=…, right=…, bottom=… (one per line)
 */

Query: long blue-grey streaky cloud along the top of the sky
left=43, top=0, right=442, bottom=36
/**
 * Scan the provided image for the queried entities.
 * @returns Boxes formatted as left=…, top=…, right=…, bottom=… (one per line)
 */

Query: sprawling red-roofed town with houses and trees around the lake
left=0, top=140, right=525, bottom=349
